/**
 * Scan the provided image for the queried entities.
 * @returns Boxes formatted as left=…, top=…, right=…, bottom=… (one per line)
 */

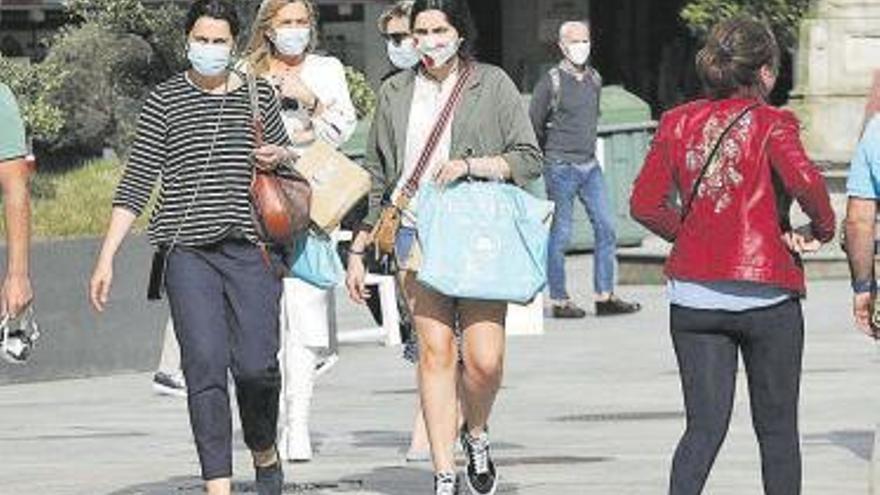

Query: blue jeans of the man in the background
left=544, top=160, right=617, bottom=300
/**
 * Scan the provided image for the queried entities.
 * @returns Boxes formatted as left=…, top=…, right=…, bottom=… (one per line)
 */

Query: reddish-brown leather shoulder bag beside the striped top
left=247, top=74, right=312, bottom=247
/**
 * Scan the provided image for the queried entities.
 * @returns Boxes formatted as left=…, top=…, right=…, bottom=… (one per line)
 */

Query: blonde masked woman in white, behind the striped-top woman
left=247, top=0, right=357, bottom=461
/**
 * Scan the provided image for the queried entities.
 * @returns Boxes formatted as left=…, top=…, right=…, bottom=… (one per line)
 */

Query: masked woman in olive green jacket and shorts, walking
left=347, top=0, right=542, bottom=494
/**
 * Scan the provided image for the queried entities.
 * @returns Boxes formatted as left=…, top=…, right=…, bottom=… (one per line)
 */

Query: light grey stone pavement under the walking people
left=0, top=257, right=880, bottom=495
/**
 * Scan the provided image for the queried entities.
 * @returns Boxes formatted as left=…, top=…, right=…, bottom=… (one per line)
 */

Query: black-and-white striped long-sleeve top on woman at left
left=113, top=73, right=290, bottom=246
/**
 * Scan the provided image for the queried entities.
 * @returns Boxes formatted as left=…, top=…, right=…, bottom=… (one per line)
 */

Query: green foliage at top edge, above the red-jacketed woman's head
left=681, top=0, right=810, bottom=49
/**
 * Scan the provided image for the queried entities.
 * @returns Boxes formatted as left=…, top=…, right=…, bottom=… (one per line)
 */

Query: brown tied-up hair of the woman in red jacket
left=697, top=16, right=780, bottom=99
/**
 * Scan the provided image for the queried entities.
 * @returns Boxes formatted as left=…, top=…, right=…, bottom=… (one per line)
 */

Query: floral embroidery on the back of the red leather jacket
left=686, top=112, right=752, bottom=214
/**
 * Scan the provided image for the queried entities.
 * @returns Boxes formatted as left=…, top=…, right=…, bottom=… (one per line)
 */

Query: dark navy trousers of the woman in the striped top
left=166, top=240, right=282, bottom=480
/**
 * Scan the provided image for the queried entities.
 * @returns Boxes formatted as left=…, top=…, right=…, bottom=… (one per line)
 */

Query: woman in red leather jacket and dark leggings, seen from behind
left=630, top=17, right=835, bottom=495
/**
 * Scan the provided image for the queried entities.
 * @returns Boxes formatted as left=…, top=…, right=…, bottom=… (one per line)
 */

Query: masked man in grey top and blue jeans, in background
left=529, top=21, right=640, bottom=318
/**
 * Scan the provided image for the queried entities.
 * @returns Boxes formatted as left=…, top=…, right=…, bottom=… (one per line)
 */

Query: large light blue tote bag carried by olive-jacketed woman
left=417, top=182, right=553, bottom=303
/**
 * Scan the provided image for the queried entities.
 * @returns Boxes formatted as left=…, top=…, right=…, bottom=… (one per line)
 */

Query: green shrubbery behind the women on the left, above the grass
left=11, top=0, right=375, bottom=156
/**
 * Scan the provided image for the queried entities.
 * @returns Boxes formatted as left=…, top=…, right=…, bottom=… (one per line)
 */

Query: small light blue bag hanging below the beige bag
left=290, top=232, right=345, bottom=289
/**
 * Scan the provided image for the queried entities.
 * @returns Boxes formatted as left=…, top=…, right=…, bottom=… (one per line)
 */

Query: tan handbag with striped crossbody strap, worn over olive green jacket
left=372, top=63, right=473, bottom=256
